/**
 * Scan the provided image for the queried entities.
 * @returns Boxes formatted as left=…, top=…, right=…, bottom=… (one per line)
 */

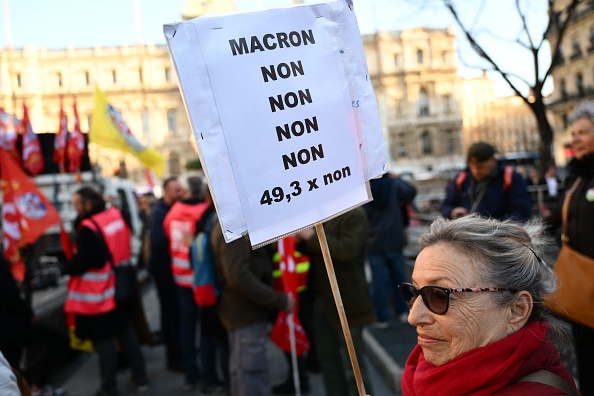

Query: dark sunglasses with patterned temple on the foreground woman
left=398, top=283, right=515, bottom=315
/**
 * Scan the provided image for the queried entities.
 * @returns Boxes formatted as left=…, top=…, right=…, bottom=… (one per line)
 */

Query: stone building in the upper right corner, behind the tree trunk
left=547, top=0, right=594, bottom=165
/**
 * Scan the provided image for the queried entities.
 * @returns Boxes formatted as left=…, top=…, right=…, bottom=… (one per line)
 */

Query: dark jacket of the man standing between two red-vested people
left=149, top=199, right=171, bottom=276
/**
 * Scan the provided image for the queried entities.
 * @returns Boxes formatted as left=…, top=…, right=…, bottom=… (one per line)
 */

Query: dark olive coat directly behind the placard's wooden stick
left=298, top=208, right=375, bottom=329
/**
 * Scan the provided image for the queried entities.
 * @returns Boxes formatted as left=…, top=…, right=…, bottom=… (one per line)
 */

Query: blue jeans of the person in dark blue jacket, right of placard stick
left=368, top=251, right=408, bottom=322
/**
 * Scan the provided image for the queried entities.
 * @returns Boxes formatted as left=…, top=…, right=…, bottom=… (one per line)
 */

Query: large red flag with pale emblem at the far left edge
left=0, top=149, right=71, bottom=278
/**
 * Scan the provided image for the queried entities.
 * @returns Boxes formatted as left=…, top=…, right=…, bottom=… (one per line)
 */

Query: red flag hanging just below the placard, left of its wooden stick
left=270, top=236, right=310, bottom=356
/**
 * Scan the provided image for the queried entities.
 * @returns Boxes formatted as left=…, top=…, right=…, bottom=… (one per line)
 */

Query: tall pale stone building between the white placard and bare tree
left=363, top=28, right=463, bottom=171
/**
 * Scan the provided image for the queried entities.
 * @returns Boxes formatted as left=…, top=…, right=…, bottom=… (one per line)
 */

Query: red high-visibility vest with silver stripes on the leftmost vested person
left=64, top=208, right=132, bottom=315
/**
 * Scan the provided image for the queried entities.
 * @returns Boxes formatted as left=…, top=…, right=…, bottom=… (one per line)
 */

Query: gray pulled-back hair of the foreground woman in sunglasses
left=419, top=214, right=563, bottom=333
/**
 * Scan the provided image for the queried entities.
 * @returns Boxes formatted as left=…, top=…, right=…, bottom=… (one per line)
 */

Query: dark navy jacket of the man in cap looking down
left=441, top=162, right=532, bottom=221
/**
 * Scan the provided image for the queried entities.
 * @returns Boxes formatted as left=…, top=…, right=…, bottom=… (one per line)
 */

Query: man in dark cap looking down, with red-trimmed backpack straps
left=441, top=142, right=532, bottom=221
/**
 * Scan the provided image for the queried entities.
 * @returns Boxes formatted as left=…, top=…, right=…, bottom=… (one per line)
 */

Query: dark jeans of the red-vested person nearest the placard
left=177, top=286, right=200, bottom=384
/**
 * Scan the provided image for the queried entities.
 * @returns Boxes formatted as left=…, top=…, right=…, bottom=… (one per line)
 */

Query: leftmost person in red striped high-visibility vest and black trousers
left=63, top=187, right=148, bottom=395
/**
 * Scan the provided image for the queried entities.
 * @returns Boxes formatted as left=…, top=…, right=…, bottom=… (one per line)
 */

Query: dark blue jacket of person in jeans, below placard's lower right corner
left=364, top=175, right=417, bottom=254
